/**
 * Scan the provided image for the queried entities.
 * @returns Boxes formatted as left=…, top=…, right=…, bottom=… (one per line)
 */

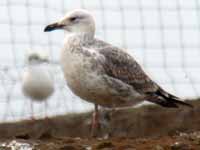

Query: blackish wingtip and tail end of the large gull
left=148, top=88, right=193, bottom=108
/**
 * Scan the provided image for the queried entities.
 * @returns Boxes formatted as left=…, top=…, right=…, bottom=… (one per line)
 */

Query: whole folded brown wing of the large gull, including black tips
left=98, top=45, right=192, bottom=107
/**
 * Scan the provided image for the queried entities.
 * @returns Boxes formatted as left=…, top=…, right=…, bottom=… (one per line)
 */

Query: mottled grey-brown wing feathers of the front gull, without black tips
left=99, top=46, right=159, bottom=94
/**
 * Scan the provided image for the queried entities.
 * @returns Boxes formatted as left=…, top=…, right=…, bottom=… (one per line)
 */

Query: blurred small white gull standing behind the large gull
left=22, top=50, right=54, bottom=119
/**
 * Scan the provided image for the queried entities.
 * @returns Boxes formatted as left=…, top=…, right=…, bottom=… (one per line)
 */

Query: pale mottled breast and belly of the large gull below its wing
left=61, top=49, right=141, bottom=107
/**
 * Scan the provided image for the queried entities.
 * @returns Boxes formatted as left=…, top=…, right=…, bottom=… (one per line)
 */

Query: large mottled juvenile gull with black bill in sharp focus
left=44, top=10, right=192, bottom=136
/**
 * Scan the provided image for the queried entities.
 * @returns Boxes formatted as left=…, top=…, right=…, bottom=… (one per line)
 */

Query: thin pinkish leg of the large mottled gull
left=91, top=104, right=100, bottom=136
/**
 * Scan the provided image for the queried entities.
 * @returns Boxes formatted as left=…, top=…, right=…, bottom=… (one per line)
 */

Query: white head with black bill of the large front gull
left=44, top=9, right=95, bottom=35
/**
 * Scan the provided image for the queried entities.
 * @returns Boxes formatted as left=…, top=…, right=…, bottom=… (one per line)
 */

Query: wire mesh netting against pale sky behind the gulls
left=0, top=0, right=200, bottom=122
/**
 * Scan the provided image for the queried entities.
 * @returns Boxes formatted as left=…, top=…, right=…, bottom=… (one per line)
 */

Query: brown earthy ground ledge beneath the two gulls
left=0, top=100, right=200, bottom=150
